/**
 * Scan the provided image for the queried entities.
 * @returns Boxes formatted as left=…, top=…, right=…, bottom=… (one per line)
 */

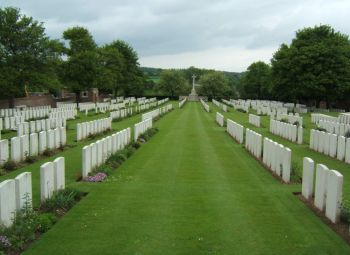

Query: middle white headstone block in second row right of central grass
left=270, top=119, right=303, bottom=144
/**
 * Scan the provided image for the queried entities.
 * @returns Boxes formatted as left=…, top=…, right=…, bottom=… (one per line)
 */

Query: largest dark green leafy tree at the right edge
left=272, top=25, right=350, bottom=106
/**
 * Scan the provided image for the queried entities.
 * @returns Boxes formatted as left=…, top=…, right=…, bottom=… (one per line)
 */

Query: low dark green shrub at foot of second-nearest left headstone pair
left=40, top=188, right=82, bottom=215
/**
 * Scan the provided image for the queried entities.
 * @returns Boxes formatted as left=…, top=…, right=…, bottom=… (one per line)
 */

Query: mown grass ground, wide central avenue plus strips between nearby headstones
left=10, top=103, right=350, bottom=254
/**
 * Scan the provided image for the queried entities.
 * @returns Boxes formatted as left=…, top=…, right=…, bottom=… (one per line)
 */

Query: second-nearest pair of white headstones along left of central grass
left=40, top=157, right=65, bottom=201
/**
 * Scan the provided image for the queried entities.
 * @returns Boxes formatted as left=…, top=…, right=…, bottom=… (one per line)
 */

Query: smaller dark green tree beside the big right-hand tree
left=241, top=61, right=271, bottom=99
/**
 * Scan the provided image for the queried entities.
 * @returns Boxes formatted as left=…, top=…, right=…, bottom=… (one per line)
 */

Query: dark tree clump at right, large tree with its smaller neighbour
left=238, top=25, right=350, bottom=106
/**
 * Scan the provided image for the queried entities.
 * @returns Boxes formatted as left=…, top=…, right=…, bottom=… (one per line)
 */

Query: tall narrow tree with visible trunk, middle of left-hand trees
left=62, top=27, right=99, bottom=103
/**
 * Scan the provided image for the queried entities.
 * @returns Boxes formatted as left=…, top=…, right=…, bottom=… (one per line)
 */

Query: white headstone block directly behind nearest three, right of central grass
left=263, top=137, right=292, bottom=183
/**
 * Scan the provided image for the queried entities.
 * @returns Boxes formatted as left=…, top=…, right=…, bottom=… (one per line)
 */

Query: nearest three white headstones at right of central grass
left=302, top=157, right=343, bottom=223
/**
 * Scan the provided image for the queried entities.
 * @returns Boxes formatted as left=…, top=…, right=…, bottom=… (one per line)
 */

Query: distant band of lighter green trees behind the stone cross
left=148, top=67, right=240, bottom=98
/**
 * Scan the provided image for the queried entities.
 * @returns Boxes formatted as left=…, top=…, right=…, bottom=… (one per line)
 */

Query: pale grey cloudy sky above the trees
left=0, top=0, right=350, bottom=72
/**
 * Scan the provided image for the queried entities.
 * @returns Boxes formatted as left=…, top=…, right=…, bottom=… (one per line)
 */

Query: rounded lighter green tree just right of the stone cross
left=198, top=71, right=231, bottom=98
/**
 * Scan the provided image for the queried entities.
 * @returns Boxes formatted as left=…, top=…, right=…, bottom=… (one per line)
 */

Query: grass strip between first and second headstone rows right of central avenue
left=209, top=103, right=350, bottom=199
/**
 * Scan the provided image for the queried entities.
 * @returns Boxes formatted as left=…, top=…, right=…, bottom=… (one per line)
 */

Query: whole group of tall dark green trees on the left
left=0, top=7, right=146, bottom=104
